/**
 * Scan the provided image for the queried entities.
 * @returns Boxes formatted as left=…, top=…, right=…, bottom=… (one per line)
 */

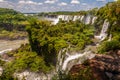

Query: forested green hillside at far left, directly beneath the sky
left=0, top=8, right=26, bottom=31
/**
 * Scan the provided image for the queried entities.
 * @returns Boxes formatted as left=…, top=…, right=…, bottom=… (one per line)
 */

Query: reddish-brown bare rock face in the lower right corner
left=69, top=50, right=120, bottom=80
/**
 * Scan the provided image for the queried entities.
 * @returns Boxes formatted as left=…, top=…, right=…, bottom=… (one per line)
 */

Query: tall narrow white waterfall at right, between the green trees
left=95, top=19, right=109, bottom=41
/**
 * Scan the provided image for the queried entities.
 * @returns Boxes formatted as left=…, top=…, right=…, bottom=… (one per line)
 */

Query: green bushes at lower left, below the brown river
left=0, top=44, right=52, bottom=80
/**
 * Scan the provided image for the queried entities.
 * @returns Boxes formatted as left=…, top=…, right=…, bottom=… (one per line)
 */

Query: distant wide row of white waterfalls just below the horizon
left=45, top=15, right=97, bottom=25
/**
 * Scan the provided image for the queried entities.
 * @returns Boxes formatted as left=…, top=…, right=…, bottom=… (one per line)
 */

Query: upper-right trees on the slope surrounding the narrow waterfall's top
left=95, top=1, right=120, bottom=34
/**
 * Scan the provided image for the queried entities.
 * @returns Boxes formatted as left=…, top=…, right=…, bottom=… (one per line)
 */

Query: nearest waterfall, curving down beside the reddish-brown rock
left=56, top=45, right=95, bottom=73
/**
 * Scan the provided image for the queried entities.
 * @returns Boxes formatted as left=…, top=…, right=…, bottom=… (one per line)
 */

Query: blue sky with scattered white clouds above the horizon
left=0, top=0, right=116, bottom=13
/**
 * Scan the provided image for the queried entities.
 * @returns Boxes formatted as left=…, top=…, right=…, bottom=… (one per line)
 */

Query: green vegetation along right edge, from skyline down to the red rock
left=97, top=1, right=120, bottom=53
